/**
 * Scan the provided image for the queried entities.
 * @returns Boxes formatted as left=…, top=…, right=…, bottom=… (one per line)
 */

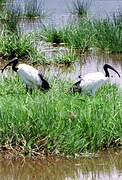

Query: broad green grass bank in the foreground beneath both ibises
left=0, top=76, right=122, bottom=156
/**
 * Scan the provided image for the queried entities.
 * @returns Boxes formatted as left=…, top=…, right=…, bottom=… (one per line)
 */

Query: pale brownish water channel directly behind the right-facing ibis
left=39, top=50, right=122, bottom=88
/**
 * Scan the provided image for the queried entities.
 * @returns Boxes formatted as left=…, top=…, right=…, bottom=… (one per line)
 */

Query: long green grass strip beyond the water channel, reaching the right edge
left=40, top=14, right=122, bottom=52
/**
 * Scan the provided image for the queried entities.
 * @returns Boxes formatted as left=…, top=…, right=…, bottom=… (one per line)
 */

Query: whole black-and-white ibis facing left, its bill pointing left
left=2, top=57, right=50, bottom=93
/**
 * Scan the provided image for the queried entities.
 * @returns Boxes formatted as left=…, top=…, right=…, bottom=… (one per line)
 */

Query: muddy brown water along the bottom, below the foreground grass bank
left=0, top=151, right=122, bottom=180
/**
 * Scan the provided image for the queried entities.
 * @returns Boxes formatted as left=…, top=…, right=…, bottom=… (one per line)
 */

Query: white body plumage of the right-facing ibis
left=80, top=72, right=109, bottom=96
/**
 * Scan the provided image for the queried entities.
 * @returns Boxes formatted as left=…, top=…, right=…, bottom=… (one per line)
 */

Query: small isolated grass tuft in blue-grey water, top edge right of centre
left=71, top=0, right=92, bottom=17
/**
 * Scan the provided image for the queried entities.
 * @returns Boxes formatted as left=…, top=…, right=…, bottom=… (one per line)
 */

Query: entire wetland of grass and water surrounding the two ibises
left=0, top=0, right=122, bottom=180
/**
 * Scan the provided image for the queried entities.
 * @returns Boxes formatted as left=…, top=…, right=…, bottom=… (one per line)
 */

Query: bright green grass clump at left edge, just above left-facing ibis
left=0, top=29, right=37, bottom=59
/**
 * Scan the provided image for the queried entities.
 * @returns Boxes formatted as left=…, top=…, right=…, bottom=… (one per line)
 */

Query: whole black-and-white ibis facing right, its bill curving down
left=70, top=64, right=120, bottom=96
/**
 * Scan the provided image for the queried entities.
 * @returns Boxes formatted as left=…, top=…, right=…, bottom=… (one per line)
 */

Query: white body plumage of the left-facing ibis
left=17, top=64, right=42, bottom=87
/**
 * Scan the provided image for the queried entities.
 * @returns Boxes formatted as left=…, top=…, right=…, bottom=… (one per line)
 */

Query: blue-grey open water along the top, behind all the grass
left=8, top=0, right=122, bottom=33
